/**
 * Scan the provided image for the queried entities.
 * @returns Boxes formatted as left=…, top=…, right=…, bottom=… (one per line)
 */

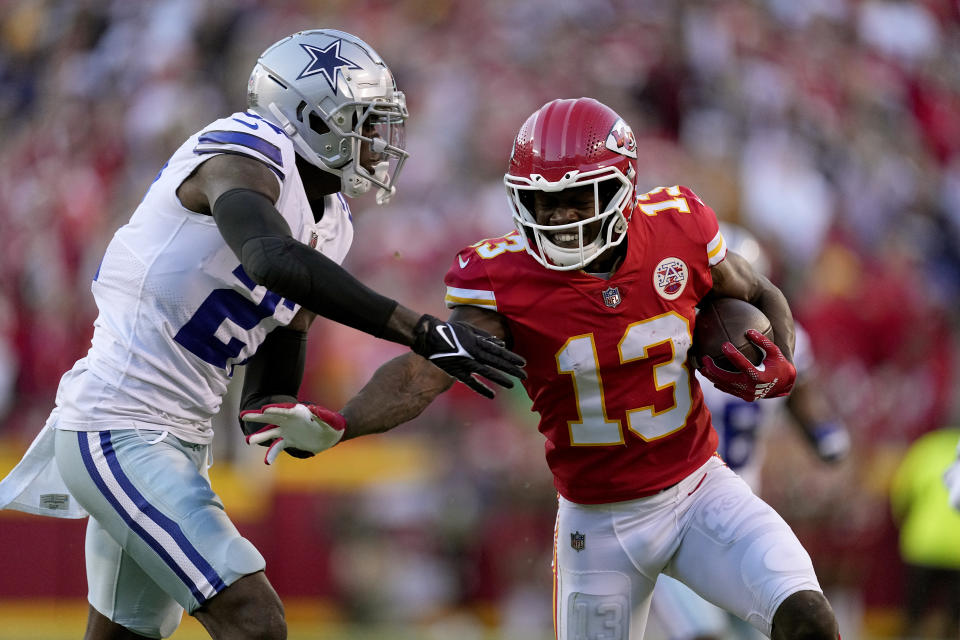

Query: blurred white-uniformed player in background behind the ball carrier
left=651, top=223, right=850, bottom=640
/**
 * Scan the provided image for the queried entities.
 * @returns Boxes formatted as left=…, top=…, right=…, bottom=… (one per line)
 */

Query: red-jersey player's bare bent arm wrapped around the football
left=703, top=251, right=796, bottom=363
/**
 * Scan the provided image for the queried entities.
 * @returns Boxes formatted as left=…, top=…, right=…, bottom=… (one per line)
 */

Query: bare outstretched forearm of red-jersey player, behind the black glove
left=340, top=353, right=454, bottom=440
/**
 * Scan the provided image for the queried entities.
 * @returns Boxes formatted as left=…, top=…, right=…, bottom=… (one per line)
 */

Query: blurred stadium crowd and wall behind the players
left=0, top=0, right=960, bottom=640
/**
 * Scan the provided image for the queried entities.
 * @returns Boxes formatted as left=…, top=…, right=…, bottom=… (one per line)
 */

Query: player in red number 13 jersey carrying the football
left=246, top=98, right=838, bottom=640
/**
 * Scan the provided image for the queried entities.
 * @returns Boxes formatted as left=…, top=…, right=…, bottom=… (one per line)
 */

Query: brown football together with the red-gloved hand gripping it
left=693, top=298, right=797, bottom=402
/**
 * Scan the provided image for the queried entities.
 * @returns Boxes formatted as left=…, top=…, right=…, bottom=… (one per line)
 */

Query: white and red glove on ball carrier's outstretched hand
left=240, top=402, right=347, bottom=464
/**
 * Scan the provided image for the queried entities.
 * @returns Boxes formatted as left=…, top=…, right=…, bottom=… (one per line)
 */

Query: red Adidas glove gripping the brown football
left=700, top=329, right=797, bottom=402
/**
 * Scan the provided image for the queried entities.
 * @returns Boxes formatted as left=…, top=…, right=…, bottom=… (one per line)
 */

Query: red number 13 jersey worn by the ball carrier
left=445, top=187, right=726, bottom=504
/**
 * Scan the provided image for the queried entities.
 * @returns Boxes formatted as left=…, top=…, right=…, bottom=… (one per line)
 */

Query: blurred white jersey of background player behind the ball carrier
left=697, top=325, right=813, bottom=492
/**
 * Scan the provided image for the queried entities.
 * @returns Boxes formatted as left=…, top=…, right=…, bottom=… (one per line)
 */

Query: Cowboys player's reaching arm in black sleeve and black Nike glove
left=178, top=155, right=524, bottom=397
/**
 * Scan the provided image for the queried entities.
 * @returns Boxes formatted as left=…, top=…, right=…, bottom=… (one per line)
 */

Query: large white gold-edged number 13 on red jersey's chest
left=556, top=311, right=693, bottom=446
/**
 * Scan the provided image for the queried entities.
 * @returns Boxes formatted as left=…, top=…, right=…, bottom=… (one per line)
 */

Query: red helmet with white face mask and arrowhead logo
left=503, top=98, right=637, bottom=271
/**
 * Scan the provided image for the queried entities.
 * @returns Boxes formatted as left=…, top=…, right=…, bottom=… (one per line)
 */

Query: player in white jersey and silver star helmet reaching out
left=0, top=30, right=525, bottom=640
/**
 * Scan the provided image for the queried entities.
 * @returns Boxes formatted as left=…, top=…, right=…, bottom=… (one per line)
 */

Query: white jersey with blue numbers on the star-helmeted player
left=57, top=113, right=353, bottom=443
